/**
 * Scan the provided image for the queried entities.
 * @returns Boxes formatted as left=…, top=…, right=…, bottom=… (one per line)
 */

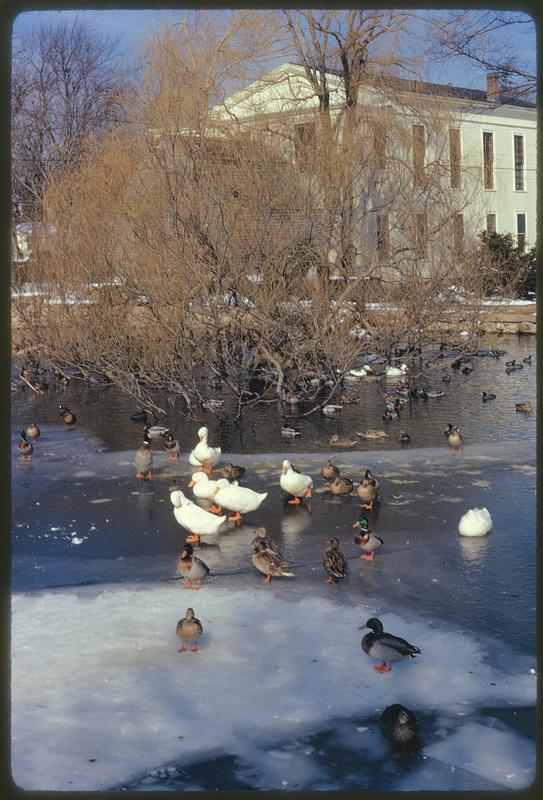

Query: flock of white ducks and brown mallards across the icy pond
left=13, top=351, right=532, bottom=745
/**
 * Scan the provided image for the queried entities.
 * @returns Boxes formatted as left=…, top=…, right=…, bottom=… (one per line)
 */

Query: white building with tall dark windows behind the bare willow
left=214, top=64, right=536, bottom=276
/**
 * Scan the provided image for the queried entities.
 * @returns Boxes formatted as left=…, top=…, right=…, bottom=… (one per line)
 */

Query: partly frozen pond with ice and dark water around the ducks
left=12, top=337, right=536, bottom=791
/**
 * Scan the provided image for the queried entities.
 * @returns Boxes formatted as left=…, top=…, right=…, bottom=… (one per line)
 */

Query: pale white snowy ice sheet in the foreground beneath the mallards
left=12, top=581, right=536, bottom=791
